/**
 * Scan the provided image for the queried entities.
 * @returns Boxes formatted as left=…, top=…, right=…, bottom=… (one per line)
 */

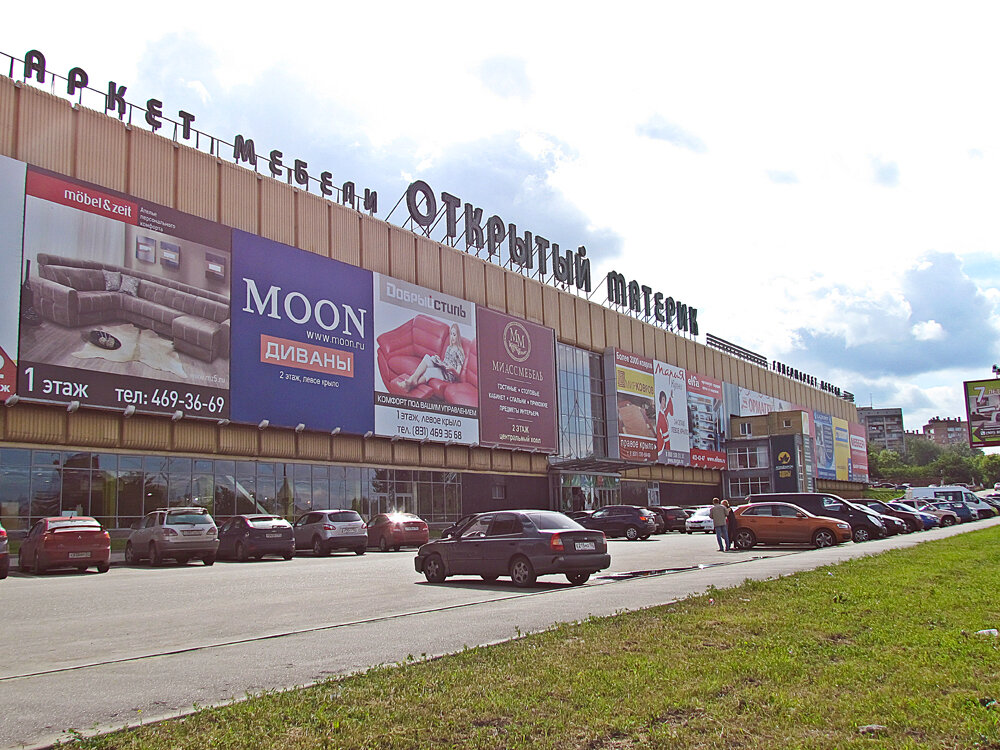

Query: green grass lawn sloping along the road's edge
left=70, top=527, right=1000, bottom=750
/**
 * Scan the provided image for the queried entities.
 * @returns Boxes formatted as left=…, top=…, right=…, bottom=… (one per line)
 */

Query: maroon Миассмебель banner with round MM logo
left=476, top=307, right=559, bottom=453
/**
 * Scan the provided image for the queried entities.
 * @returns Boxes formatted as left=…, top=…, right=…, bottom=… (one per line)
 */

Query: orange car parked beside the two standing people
left=733, top=503, right=851, bottom=549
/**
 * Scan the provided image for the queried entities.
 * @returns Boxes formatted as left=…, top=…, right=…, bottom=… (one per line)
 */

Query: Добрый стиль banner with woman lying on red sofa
left=373, top=273, right=479, bottom=445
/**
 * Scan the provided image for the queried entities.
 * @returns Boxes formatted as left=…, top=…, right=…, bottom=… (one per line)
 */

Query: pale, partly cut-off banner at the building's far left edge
left=0, top=156, right=31, bottom=402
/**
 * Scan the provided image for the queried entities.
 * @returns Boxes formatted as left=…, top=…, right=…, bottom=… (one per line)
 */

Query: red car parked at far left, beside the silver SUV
left=18, top=516, right=111, bottom=575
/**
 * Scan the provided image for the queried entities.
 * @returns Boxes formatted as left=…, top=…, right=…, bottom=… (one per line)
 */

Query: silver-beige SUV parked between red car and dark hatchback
left=125, top=506, right=219, bottom=567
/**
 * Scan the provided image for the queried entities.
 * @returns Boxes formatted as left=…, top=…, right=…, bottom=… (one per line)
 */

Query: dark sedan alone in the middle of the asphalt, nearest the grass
left=413, top=510, right=611, bottom=587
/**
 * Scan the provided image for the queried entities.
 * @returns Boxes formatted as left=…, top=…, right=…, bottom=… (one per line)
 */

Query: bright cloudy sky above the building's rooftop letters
left=0, top=0, right=1000, bottom=430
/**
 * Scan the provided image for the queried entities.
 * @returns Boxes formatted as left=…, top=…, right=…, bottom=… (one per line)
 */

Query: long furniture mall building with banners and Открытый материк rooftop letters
left=0, top=54, right=867, bottom=531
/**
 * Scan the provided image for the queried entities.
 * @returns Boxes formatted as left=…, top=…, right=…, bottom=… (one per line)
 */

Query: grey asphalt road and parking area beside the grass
left=0, top=518, right=1000, bottom=748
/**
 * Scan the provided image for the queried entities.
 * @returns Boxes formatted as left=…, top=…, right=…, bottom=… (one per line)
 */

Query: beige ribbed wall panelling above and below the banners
left=0, top=78, right=858, bottom=484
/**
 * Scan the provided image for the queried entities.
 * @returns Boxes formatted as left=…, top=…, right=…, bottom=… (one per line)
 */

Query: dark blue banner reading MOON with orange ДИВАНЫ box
left=232, top=229, right=375, bottom=435
